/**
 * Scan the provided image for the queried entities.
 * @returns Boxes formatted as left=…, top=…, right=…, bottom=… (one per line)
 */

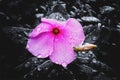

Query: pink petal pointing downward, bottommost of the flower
left=50, top=35, right=75, bottom=67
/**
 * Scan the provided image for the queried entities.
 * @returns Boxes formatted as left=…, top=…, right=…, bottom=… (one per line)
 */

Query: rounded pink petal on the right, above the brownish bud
left=64, top=18, right=85, bottom=47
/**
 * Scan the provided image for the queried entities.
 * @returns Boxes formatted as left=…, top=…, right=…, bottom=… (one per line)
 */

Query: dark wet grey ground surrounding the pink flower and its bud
left=0, top=0, right=120, bottom=80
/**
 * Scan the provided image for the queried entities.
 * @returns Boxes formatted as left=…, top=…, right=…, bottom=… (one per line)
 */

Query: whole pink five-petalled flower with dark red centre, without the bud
left=26, top=18, right=85, bottom=67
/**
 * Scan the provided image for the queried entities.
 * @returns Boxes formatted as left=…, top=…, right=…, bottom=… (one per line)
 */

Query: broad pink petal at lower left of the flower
left=26, top=32, right=54, bottom=58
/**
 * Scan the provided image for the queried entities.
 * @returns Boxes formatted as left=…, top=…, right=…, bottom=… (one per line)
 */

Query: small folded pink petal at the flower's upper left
left=29, top=23, right=52, bottom=38
